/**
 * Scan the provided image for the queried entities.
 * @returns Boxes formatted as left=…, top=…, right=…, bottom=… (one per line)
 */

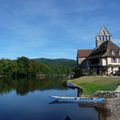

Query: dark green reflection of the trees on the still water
left=0, top=78, right=66, bottom=95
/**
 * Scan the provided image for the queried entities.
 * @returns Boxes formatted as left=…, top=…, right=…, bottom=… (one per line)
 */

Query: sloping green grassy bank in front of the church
left=68, top=76, right=120, bottom=95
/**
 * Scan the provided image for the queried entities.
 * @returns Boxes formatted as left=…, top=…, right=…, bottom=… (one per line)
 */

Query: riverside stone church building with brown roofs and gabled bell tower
left=77, top=27, right=120, bottom=75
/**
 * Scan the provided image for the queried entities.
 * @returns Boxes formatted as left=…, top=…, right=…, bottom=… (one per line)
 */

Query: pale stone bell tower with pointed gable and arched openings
left=96, top=27, right=112, bottom=47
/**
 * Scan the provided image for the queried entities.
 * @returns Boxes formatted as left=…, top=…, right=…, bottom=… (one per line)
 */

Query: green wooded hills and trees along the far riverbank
left=0, top=56, right=75, bottom=78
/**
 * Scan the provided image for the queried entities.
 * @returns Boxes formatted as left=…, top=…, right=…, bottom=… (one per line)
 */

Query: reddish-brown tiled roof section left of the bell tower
left=77, top=49, right=92, bottom=58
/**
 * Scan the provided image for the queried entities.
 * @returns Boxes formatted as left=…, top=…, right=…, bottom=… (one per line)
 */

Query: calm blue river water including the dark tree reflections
left=0, top=79, right=98, bottom=120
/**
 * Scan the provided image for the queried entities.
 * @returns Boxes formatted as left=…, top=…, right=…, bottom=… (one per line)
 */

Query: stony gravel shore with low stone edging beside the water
left=94, top=91, right=120, bottom=120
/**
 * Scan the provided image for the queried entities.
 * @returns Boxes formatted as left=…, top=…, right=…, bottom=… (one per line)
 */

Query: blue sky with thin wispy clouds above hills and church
left=0, top=0, right=120, bottom=59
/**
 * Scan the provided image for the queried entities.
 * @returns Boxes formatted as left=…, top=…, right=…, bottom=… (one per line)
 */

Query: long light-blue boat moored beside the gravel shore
left=51, top=96, right=105, bottom=103
